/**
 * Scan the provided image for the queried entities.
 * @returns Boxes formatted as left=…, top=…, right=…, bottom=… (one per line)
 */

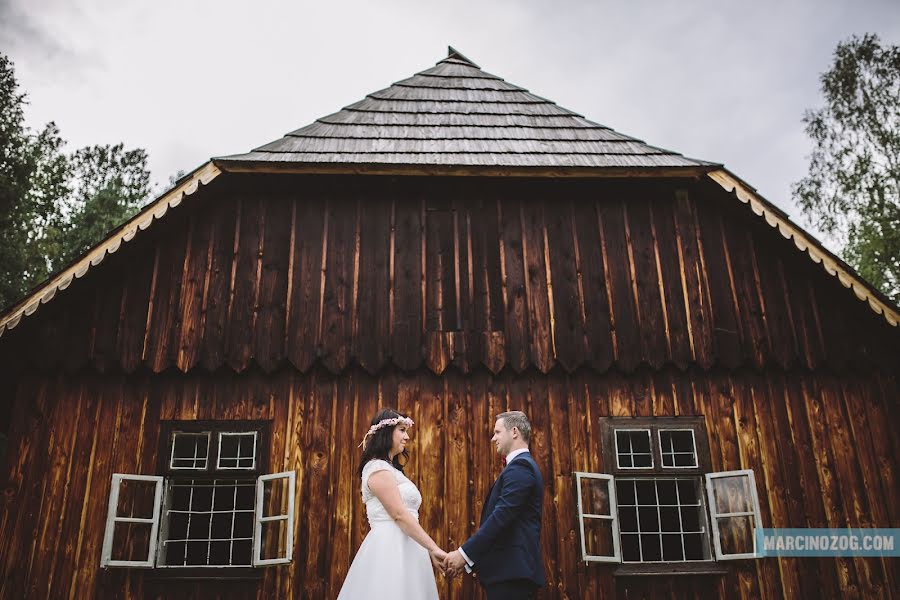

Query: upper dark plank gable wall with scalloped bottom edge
left=4, top=176, right=900, bottom=374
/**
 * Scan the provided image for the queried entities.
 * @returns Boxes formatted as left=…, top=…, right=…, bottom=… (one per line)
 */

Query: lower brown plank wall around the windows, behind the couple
left=0, top=368, right=900, bottom=598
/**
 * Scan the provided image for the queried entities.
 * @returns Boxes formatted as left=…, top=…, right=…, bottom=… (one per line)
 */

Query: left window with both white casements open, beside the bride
left=101, top=421, right=295, bottom=569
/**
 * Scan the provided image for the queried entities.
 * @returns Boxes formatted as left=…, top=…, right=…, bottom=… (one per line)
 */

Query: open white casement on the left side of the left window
left=100, top=473, right=163, bottom=568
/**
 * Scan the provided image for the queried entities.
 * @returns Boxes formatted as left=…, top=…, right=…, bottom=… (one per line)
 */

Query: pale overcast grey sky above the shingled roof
left=0, top=0, right=900, bottom=246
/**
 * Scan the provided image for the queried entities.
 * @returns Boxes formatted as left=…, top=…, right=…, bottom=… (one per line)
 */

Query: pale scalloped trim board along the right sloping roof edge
left=707, top=169, right=900, bottom=327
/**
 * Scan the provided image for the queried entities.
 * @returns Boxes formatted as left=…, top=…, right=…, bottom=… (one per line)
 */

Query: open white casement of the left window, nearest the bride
left=253, top=471, right=296, bottom=567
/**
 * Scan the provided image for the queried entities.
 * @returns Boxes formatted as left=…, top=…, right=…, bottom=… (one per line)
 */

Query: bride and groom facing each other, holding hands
left=338, top=409, right=545, bottom=600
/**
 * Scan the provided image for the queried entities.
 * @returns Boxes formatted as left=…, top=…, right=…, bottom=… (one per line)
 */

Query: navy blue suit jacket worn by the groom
left=462, top=452, right=546, bottom=586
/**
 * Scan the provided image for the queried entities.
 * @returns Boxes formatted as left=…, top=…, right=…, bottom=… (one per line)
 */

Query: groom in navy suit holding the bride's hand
left=444, top=410, right=545, bottom=600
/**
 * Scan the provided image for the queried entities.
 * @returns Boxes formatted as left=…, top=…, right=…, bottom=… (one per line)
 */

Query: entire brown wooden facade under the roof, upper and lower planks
left=0, top=175, right=900, bottom=598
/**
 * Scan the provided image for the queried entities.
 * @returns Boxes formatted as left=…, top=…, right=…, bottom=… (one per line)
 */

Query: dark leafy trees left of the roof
left=0, top=54, right=150, bottom=308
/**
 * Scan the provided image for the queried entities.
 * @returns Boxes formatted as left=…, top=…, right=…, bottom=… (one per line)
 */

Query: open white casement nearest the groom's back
left=575, top=472, right=622, bottom=563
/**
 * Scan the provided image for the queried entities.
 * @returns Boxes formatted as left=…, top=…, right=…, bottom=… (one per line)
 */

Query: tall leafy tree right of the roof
left=793, top=34, right=900, bottom=302
